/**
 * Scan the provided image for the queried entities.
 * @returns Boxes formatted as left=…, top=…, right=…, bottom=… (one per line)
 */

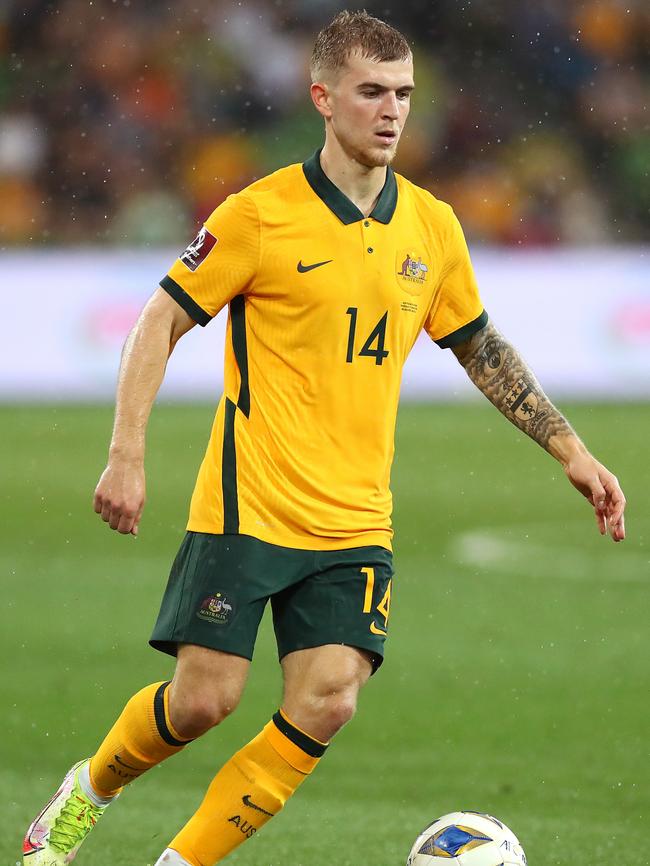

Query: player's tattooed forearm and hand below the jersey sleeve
left=453, top=323, right=625, bottom=541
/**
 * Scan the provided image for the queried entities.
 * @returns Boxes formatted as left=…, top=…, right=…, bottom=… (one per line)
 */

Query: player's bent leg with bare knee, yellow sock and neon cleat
left=23, top=645, right=250, bottom=866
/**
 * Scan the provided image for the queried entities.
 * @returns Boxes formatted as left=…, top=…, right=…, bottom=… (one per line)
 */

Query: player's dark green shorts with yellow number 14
left=149, top=532, right=393, bottom=670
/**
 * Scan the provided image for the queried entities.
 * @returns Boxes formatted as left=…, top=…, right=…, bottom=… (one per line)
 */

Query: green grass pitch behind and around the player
left=0, top=403, right=650, bottom=866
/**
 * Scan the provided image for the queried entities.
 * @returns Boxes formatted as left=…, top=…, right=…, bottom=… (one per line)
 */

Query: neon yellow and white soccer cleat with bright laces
left=23, top=758, right=111, bottom=866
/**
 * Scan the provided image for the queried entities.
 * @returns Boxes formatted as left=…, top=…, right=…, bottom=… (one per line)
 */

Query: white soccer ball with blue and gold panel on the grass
left=406, top=812, right=526, bottom=866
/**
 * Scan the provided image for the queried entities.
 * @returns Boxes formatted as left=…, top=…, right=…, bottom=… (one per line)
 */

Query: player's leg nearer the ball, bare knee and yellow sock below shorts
left=157, top=646, right=372, bottom=866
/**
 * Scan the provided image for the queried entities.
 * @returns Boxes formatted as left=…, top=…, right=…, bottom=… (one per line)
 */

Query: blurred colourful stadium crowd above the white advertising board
left=0, top=0, right=650, bottom=247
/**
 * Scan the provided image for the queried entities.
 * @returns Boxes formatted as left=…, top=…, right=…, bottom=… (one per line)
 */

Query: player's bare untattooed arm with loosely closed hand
left=93, top=289, right=196, bottom=535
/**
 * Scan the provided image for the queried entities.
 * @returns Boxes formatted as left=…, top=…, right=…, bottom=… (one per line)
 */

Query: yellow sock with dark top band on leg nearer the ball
left=169, top=711, right=327, bottom=866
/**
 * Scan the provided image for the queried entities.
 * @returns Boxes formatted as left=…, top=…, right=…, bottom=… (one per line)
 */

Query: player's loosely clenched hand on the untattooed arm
left=93, top=461, right=145, bottom=535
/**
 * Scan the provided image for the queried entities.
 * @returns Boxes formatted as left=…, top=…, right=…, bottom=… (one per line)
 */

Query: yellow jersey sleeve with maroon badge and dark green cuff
left=160, top=193, right=260, bottom=325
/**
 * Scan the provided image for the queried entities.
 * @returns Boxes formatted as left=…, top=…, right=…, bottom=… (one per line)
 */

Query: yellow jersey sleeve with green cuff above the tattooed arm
left=424, top=208, right=488, bottom=349
